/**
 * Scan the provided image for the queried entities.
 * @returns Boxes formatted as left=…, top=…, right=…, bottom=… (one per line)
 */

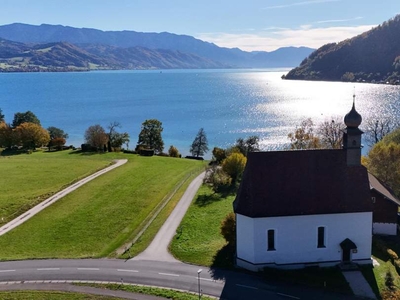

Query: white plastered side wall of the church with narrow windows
left=236, top=212, right=372, bottom=265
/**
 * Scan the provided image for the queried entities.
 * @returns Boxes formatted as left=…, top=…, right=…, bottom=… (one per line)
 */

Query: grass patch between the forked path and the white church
left=170, top=186, right=234, bottom=267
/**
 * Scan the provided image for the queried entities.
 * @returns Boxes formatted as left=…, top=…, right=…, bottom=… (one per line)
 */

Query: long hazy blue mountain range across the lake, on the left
left=0, top=23, right=314, bottom=71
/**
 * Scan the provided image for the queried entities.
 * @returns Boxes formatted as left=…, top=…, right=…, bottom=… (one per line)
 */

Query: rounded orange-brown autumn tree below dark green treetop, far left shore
left=15, top=122, right=50, bottom=149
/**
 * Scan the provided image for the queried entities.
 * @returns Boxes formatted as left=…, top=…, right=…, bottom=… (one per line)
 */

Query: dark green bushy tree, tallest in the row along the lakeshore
left=138, top=119, right=164, bottom=153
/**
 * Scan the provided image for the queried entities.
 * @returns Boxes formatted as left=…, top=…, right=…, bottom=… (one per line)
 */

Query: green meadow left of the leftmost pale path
left=0, top=151, right=112, bottom=225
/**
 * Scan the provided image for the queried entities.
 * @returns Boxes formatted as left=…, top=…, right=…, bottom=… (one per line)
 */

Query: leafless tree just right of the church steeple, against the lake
left=365, top=117, right=400, bottom=146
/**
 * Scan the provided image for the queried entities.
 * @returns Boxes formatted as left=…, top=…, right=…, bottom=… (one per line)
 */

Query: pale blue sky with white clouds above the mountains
left=0, top=0, right=400, bottom=51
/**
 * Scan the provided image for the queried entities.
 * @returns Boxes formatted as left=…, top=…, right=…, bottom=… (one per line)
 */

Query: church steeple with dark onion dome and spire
left=343, top=94, right=364, bottom=166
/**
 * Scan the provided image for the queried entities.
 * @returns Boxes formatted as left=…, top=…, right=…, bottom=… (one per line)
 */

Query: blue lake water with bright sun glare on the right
left=0, top=70, right=400, bottom=157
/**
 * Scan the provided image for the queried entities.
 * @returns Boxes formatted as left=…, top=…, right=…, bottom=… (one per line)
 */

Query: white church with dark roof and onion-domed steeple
left=234, top=103, right=372, bottom=270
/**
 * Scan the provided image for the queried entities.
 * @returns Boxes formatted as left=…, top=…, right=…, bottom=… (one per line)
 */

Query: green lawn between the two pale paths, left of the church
left=0, top=153, right=204, bottom=260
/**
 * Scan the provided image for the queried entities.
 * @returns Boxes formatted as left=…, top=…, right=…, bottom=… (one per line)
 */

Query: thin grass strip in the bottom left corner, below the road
left=0, top=291, right=122, bottom=300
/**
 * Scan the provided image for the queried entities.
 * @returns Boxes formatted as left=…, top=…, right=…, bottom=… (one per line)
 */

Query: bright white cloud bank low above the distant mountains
left=196, top=25, right=376, bottom=51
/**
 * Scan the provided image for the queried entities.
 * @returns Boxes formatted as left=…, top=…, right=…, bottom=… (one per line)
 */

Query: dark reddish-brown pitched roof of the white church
left=234, top=150, right=372, bottom=218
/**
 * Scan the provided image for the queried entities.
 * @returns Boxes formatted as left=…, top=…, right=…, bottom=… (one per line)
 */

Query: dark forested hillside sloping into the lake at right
left=285, top=15, right=400, bottom=84
